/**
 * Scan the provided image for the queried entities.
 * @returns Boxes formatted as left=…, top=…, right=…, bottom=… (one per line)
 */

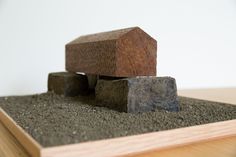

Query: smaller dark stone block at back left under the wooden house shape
left=48, top=72, right=88, bottom=97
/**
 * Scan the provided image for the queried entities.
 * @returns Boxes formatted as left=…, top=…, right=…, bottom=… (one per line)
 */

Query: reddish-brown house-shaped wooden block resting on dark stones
left=66, top=27, right=157, bottom=77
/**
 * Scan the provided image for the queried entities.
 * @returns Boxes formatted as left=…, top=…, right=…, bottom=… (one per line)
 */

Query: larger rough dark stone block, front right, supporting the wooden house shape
left=95, top=77, right=179, bottom=113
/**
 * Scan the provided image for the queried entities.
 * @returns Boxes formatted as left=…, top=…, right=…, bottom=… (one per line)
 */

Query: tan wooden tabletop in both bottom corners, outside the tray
left=0, top=119, right=236, bottom=157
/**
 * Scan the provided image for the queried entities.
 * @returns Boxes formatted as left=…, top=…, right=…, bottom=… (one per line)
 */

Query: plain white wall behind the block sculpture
left=0, top=0, right=236, bottom=95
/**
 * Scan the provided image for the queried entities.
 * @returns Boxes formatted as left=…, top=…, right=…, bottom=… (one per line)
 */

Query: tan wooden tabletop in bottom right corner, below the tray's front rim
left=126, top=136, right=236, bottom=157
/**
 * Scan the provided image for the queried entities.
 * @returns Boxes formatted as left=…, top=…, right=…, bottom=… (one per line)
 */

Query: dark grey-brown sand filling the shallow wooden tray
left=0, top=93, right=236, bottom=147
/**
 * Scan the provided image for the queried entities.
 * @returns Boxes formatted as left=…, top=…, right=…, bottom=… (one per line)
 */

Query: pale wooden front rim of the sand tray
left=41, top=120, right=236, bottom=157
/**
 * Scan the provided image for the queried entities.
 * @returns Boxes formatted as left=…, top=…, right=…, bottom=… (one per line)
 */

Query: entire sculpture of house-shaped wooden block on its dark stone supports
left=48, top=27, right=179, bottom=113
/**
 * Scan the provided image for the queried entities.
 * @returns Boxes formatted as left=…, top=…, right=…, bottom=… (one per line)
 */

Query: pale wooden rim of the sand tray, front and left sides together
left=0, top=92, right=236, bottom=157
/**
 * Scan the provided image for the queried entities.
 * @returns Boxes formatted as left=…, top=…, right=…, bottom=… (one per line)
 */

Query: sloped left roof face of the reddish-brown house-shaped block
left=67, top=27, right=137, bottom=45
